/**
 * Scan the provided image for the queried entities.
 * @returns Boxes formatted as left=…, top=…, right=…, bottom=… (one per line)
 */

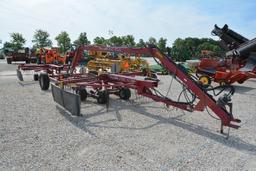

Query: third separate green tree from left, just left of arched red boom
left=55, top=31, right=71, bottom=53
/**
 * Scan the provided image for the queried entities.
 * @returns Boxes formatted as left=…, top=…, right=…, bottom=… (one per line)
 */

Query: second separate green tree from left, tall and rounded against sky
left=32, top=29, right=52, bottom=48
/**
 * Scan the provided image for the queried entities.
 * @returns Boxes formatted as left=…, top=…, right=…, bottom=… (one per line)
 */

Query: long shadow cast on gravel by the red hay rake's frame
left=57, top=97, right=256, bottom=155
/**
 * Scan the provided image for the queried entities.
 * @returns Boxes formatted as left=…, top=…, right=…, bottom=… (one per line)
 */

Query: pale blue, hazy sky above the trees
left=0, top=0, right=256, bottom=46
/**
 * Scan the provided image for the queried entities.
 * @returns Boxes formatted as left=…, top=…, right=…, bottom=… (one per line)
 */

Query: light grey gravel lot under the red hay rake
left=0, top=62, right=256, bottom=171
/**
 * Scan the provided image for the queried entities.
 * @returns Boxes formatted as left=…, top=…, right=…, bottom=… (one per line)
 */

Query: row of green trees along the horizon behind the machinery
left=0, top=29, right=223, bottom=61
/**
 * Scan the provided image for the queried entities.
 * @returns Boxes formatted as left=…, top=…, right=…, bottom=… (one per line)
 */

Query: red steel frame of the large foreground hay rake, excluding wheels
left=19, top=45, right=240, bottom=129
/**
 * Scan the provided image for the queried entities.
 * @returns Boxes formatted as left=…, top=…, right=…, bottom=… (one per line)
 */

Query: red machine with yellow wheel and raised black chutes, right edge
left=197, top=25, right=256, bottom=87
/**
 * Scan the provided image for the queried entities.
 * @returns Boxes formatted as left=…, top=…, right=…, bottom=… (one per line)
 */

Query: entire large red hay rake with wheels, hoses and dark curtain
left=17, top=45, right=241, bottom=133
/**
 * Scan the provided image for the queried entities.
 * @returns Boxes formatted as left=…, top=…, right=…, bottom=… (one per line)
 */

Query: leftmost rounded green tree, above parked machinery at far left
left=4, top=33, right=26, bottom=51
